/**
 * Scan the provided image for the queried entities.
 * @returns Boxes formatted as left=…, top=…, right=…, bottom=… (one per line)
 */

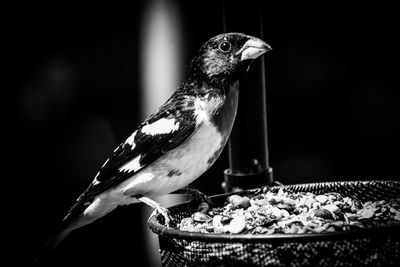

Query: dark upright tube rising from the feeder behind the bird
left=222, top=1, right=273, bottom=192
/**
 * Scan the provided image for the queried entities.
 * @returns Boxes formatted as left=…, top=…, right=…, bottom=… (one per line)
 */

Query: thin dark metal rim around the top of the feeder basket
left=148, top=180, right=400, bottom=243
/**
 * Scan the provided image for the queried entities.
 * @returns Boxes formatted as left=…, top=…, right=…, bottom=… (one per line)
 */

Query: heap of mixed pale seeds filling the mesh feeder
left=177, top=188, right=400, bottom=234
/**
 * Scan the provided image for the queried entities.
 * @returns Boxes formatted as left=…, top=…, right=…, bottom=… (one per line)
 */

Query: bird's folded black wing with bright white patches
left=66, top=97, right=196, bottom=221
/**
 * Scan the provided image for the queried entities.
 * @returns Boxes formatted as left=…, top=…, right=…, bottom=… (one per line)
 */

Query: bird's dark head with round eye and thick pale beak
left=189, top=33, right=271, bottom=88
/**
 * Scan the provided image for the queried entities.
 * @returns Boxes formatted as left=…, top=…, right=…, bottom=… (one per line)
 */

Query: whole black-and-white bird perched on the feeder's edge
left=40, top=33, right=271, bottom=258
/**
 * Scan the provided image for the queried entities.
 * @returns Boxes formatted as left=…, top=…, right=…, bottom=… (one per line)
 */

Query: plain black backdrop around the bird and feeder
left=10, top=1, right=400, bottom=266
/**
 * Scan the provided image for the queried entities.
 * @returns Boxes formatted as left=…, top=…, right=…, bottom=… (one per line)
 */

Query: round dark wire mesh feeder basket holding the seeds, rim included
left=148, top=181, right=400, bottom=266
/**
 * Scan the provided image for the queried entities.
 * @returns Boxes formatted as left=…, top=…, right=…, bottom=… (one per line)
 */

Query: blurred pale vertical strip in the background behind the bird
left=140, top=0, right=183, bottom=266
